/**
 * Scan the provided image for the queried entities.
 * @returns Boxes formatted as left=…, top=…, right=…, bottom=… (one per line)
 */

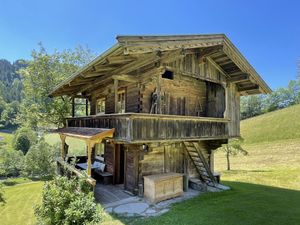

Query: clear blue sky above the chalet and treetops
left=0, top=0, right=300, bottom=88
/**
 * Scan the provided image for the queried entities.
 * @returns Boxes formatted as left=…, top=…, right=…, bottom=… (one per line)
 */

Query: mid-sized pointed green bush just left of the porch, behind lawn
left=24, top=138, right=59, bottom=177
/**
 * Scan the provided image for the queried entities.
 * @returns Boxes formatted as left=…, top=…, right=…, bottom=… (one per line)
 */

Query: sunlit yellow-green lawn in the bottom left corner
left=0, top=182, right=43, bottom=225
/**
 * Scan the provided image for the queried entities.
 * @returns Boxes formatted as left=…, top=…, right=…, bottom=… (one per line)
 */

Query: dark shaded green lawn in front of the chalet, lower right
left=111, top=182, right=300, bottom=225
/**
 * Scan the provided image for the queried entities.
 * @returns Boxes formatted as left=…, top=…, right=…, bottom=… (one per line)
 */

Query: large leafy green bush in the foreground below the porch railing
left=35, top=177, right=101, bottom=225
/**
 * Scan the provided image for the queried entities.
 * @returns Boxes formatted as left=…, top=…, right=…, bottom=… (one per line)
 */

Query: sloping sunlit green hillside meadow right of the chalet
left=241, top=104, right=300, bottom=144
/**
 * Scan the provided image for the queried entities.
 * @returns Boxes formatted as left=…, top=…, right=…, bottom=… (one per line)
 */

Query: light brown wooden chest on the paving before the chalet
left=144, top=173, right=183, bottom=203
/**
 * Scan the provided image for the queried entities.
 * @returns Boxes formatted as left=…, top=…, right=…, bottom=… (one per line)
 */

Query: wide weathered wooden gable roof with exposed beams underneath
left=50, top=34, right=272, bottom=96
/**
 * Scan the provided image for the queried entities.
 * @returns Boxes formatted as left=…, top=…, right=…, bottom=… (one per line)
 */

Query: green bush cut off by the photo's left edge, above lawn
left=0, top=145, right=24, bottom=177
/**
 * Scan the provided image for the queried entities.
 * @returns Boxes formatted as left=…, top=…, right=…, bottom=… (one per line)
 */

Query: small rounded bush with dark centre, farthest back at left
left=13, top=127, right=37, bottom=154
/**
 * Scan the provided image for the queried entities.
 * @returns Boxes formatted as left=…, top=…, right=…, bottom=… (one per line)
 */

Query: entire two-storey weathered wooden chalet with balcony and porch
left=51, top=34, right=271, bottom=200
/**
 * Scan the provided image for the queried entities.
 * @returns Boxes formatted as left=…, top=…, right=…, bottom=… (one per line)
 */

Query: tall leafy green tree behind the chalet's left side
left=18, top=44, right=93, bottom=129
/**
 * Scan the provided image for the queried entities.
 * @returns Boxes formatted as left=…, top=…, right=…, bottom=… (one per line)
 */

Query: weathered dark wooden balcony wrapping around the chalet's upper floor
left=66, top=113, right=229, bottom=143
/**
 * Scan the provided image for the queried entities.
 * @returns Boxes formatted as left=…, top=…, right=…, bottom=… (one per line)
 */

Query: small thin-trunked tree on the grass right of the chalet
left=219, top=138, right=248, bottom=170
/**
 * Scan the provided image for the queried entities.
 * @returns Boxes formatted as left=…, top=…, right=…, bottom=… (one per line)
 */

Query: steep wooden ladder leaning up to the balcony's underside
left=183, top=141, right=217, bottom=187
